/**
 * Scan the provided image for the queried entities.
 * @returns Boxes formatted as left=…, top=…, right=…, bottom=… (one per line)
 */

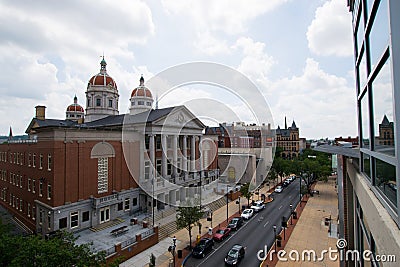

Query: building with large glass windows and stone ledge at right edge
left=317, top=0, right=400, bottom=266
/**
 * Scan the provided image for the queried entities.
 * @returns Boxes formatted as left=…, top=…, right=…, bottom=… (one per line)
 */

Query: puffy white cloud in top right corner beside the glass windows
left=307, top=0, right=353, bottom=56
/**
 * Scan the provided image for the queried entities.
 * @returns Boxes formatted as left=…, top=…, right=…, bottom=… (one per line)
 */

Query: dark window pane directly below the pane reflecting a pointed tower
left=375, top=159, right=398, bottom=207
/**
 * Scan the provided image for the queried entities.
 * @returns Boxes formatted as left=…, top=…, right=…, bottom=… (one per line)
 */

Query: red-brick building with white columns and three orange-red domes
left=0, top=58, right=219, bottom=237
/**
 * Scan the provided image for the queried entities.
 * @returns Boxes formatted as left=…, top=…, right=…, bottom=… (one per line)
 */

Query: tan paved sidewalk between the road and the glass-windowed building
left=263, top=177, right=339, bottom=267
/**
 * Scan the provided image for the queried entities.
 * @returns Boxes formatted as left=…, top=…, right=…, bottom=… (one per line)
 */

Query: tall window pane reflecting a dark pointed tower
left=372, top=58, right=395, bottom=156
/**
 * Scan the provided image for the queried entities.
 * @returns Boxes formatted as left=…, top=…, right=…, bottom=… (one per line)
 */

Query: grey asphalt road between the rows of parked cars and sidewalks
left=185, top=179, right=300, bottom=267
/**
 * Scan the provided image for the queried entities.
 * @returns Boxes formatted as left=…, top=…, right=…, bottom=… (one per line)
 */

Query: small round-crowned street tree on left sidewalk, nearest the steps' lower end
left=176, top=201, right=204, bottom=248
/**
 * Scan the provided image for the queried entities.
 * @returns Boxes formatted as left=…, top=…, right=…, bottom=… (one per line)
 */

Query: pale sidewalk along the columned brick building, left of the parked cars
left=120, top=181, right=275, bottom=267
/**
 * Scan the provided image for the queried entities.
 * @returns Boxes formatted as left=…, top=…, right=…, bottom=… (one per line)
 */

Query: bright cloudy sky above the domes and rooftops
left=0, top=0, right=357, bottom=138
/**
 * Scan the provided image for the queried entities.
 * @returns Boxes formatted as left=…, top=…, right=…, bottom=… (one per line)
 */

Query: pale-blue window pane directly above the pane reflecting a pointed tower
left=368, top=0, right=389, bottom=69
